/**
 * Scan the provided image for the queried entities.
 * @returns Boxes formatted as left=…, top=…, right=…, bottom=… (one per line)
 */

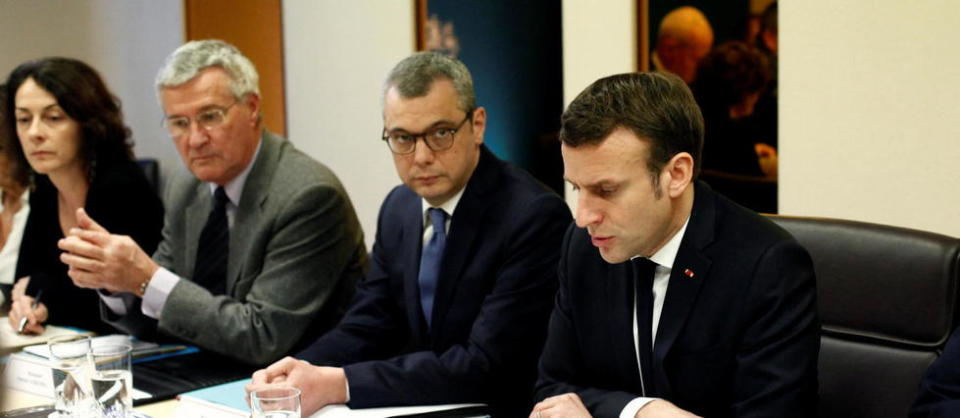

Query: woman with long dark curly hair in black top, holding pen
left=3, top=58, right=163, bottom=333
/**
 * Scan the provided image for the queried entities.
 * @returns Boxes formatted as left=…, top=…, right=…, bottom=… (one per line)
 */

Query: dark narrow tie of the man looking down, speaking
left=633, top=257, right=657, bottom=397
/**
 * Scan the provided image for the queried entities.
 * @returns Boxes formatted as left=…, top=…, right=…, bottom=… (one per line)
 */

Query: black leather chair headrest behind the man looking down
left=770, top=216, right=960, bottom=347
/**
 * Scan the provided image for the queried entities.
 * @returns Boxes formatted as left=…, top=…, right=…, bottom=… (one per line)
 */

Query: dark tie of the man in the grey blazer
left=193, top=186, right=230, bottom=295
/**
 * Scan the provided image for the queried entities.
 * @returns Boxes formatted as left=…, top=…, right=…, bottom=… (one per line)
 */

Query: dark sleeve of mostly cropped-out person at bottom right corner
left=910, top=328, right=960, bottom=418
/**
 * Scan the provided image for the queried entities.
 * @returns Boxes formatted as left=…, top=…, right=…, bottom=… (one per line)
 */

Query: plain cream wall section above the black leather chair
left=780, top=0, right=960, bottom=236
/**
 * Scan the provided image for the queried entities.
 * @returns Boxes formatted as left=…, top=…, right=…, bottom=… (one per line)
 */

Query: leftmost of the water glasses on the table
left=47, top=335, right=96, bottom=417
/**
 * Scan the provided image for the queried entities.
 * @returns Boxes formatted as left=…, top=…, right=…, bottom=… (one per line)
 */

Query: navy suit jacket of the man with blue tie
left=298, top=147, right=571, bottom=416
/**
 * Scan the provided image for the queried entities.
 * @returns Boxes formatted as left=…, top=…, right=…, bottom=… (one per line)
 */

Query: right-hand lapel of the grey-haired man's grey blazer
left=226, top=131, right=282, bottom=295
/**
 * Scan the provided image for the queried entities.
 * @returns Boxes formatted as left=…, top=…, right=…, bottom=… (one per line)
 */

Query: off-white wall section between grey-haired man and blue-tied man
left=283, top=0, right=414, bottom=247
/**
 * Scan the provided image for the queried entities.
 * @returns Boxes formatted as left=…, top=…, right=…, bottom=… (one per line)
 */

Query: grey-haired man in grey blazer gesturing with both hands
left=60, top=40, right=367, bottom=366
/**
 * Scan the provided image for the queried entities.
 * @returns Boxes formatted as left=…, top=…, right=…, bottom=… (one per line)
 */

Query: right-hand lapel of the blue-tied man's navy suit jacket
left=431, top=145, right=500, bottom=334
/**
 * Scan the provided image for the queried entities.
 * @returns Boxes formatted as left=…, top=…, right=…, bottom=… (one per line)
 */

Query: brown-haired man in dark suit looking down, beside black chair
left=531, top=73, right=820, bottom=418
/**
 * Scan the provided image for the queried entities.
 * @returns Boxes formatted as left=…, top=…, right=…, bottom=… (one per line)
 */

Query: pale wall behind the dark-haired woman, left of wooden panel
left=0, top=0, right=183, bottom=190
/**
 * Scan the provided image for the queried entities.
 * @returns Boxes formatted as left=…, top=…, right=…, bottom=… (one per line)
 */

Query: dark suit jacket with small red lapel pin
left=537, top=183, right=820, bottom=417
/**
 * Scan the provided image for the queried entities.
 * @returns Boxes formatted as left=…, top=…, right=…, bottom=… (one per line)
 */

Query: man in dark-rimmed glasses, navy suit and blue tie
left=248, top=53, right=571, bottom=416
